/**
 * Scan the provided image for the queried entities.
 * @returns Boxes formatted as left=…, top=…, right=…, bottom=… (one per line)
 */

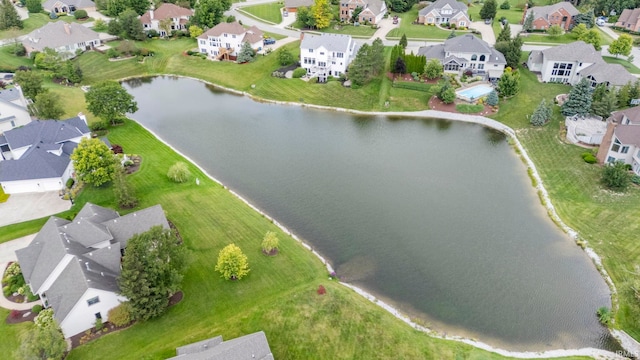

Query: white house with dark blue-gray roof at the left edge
left=0, top=114, right=91, bottom=194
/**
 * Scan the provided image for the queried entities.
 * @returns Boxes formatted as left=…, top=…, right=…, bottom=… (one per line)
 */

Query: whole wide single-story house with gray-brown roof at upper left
left=22, top=21, right=101, bottom=59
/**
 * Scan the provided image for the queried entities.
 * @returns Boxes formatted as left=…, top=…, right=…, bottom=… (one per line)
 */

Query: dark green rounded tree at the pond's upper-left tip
left=85, top=81, right=138, bottom=126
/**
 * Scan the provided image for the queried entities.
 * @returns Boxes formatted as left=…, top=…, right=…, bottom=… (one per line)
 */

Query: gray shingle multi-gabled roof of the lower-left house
left=16, top=203, right=169, bottom=322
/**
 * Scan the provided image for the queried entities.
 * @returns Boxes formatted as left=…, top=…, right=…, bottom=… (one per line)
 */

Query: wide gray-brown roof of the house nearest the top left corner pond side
left=22, top=21, right=100, bottom=50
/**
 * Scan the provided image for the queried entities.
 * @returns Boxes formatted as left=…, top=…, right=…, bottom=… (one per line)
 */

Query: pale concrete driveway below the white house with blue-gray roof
left=0, top=191, right=71, bottom=228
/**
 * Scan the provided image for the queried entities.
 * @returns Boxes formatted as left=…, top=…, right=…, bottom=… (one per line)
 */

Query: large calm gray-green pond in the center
left=124, top=77, right=613, bottom=351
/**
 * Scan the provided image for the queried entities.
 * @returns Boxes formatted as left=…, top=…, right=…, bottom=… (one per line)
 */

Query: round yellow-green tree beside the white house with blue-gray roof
left=71, top=138, right=116, bottom=186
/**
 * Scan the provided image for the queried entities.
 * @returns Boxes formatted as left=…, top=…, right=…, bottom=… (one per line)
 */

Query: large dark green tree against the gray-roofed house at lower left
left=118, top=226, right=186, bottom=320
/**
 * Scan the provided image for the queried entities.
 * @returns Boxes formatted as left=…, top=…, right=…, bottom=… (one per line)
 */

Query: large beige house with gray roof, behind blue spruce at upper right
left=527, top=41, right=637, bottom=88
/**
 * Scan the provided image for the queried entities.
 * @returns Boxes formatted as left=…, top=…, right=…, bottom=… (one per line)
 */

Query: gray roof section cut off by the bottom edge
left=169, top=331, right=273, bottom=360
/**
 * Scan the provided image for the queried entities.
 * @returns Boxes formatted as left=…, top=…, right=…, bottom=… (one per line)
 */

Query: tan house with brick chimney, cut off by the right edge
left=596, top=106, right=640, bottom=176
